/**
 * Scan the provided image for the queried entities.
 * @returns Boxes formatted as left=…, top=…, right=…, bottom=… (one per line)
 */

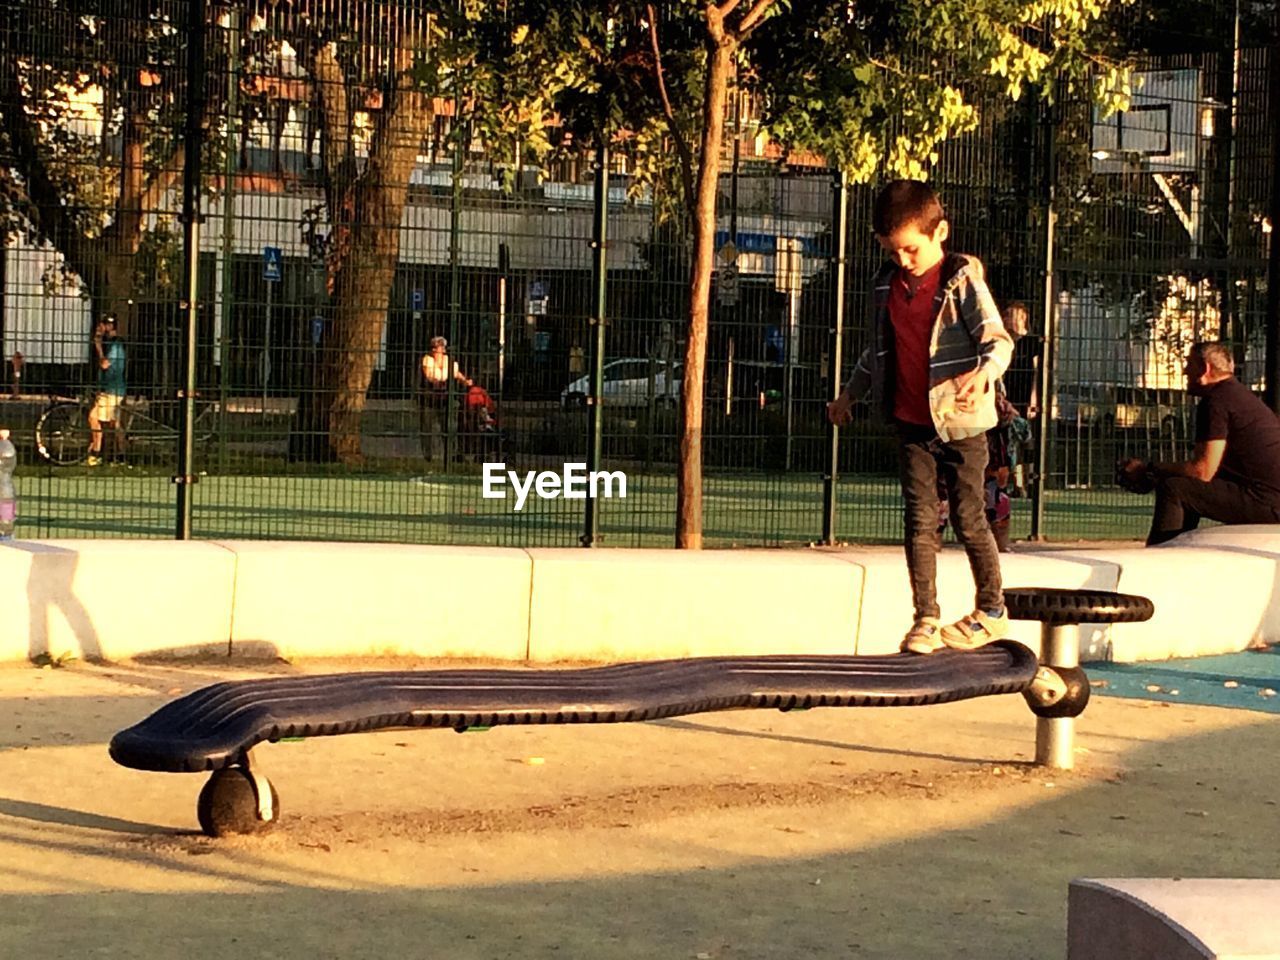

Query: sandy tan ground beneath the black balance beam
left=0, top=662, right=1280, bottom=960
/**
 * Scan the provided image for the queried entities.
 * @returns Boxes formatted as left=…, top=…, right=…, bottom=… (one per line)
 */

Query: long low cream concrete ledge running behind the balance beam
left=0, top=525, right=1280, bottom=662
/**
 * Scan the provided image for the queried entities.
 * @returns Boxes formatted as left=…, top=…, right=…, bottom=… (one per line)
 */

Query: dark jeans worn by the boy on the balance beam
left=897, top=422, right=1005, bottom=618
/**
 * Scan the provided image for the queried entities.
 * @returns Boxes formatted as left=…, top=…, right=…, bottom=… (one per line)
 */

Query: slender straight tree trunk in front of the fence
left=676, top=28, right=737, bottom=550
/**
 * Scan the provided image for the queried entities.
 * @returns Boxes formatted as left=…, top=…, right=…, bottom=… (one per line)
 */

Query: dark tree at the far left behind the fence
left=0, top=0, right=216, bottom=334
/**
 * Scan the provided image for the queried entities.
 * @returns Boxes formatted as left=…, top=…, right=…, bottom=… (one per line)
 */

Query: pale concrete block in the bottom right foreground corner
left=1066, top=879, right=1280, bottom=960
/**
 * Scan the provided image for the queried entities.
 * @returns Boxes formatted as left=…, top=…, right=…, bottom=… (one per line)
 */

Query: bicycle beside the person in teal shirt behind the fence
left=36, top=397, right=218, bottom=467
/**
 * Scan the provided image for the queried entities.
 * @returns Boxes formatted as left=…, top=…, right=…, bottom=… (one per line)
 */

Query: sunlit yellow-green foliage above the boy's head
left=748, top=0, right=1130, bottom=182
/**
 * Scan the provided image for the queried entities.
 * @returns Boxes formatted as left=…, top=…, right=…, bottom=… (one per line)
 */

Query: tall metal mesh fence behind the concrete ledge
left=0, top=0, right=1276, bottom=545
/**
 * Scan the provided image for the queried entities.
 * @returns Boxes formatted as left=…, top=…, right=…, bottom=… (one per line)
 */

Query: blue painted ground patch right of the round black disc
left=1084, top=648, right=1280, bottom=713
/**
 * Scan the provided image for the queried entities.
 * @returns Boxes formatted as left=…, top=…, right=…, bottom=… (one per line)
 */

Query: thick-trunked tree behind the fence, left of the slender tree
left=272, top=0, right=586, bottom=463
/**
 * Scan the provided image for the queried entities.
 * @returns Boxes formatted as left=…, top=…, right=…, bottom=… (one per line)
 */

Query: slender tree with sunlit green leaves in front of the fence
left=524, top=0, right=1128, bottom=548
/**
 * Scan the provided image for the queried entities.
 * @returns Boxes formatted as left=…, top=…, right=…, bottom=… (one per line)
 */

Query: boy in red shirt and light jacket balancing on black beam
left=827, top=180, right=1014, bottom=654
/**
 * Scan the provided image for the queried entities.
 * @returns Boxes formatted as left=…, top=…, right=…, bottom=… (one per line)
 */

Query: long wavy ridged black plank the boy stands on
left=111, top=641, right=1036, bottom=773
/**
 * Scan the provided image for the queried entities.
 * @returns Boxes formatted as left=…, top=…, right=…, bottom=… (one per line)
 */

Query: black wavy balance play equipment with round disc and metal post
left=110, top=590, right=1153, bottom=836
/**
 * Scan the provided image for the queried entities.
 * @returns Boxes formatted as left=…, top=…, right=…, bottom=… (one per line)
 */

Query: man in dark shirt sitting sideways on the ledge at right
left=1121, top=343, right=1280, bottom=547
